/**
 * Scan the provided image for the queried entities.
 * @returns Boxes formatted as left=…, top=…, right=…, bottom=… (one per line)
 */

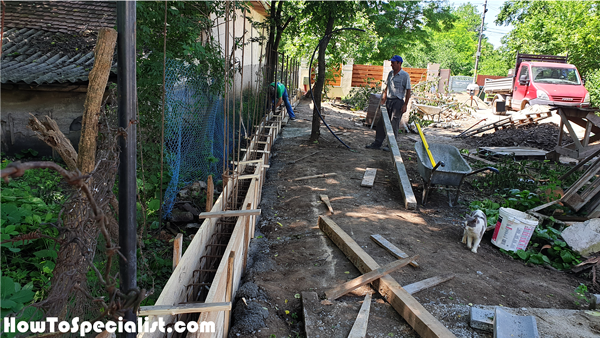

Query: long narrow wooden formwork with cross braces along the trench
left=138, top=113, right=283, bottom=338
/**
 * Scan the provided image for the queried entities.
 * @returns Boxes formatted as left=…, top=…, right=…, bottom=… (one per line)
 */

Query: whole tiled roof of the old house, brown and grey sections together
left=0, top=1, right=116, bottom=85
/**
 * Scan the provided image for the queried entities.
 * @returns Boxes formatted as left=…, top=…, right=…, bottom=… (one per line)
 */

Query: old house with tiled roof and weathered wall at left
left=0, top=0, right=116, bottom=155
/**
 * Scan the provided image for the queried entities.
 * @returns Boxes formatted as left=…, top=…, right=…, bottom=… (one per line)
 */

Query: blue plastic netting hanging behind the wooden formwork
left=163, top=60, right=230, bottom=217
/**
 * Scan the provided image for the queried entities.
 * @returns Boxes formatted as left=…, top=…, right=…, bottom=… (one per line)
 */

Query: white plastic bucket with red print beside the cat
left=492, top=208, right=538, bottom=251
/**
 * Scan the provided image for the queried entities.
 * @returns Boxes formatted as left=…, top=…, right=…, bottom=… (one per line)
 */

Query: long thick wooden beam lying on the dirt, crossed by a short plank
left=319, top=217, right=456, bottom=338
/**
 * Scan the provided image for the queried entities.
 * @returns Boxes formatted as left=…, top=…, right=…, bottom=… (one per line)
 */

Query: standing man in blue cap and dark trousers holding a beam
left=367, top=55, right=410, bottom=150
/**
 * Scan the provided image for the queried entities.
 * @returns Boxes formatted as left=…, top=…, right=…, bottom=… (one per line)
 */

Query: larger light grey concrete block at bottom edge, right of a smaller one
left=494, top=307, right=540, bottom=338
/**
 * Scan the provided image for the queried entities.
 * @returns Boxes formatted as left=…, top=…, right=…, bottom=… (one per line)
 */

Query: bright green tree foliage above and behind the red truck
left=496, top=0, right=600, bottom=74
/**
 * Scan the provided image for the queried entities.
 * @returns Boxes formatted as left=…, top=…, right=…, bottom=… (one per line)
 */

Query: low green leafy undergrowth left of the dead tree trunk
left=0, top=160, right=65, bottom=306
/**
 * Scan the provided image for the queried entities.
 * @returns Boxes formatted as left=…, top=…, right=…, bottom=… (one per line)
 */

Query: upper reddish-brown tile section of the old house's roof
left=4, top=0, right=117, bottom=33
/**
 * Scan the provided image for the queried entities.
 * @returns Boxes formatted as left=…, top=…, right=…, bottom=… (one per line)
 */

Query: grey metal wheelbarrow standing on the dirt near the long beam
left=415, top=142, right=498, bottom=207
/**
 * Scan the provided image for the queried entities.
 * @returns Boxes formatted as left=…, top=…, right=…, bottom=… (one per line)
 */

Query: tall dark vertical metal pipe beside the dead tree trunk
left=117, top=1, right=137, bottom=338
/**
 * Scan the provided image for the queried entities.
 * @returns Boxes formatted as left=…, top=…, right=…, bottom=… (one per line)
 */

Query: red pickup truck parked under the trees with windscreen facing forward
left=483, top=54, right=590, bottom=110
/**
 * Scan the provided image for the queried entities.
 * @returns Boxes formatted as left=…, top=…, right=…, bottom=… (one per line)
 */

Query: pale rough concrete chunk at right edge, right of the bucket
left=562, top=218, right=600, bottom=256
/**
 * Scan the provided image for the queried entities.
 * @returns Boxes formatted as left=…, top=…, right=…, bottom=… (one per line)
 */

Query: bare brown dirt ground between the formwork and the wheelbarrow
left=230, top=100, right=585, bottom=338
